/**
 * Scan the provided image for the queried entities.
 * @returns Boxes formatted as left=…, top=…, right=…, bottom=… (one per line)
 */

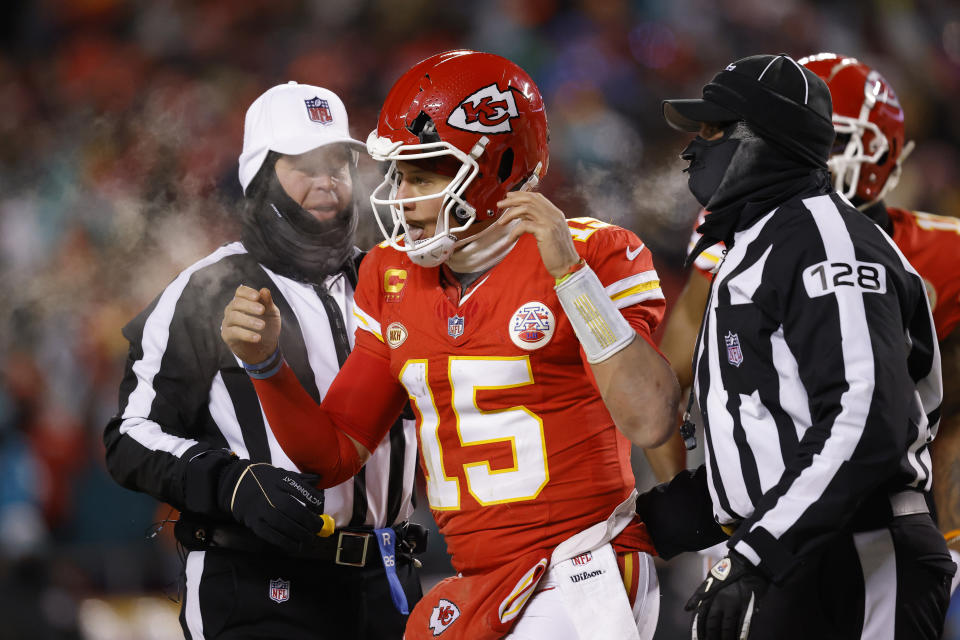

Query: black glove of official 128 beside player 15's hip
left=637, top=465, right=727, bottom=560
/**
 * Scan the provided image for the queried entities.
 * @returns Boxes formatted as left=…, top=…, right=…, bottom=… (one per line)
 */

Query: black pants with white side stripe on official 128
left=750, top=514, right=954, bottom=640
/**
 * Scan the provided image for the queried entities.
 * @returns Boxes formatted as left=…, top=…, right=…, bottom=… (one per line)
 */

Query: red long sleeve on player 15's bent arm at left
left=253, top=348, right=407, bottom=487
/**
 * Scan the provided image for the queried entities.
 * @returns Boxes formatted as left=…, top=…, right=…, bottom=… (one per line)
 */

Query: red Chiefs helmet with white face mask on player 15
left=367, top=50, right=549, bottom=267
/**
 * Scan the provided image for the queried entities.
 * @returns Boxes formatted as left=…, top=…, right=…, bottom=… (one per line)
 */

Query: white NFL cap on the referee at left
left=240, top=80, right=366, bottom=193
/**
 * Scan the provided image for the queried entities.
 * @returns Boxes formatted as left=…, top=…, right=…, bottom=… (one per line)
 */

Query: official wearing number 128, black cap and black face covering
left=654, top=55, right=955, bottom=640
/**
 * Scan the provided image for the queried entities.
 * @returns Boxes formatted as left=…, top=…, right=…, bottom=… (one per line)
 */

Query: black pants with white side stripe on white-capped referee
left=180, top=550, right=423, bottom=640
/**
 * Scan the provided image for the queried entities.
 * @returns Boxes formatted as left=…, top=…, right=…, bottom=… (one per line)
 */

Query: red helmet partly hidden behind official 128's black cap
left=799, top=53, right=913, bottom=209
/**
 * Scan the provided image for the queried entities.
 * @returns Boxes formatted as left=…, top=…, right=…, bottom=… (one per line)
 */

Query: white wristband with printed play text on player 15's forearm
left=554, top=266, right=637, bottom=364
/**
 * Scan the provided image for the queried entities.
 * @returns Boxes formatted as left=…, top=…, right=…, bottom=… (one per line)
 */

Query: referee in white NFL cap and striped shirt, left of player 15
left=104, top=82, right=426, bottom=640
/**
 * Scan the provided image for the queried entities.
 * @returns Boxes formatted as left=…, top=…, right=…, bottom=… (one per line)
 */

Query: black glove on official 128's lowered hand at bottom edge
left=684, top=550, right=769, bottom=640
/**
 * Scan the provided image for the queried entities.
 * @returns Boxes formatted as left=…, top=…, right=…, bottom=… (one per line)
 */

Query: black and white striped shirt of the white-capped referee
left=104, top=242, right=416, bottom=527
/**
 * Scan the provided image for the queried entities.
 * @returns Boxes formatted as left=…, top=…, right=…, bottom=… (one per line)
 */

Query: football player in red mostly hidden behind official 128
left=660, top=53, right=960, bottom=589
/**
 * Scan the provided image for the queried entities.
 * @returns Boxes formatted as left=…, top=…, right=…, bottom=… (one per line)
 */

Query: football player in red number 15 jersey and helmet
left=222, top=51, right=679, bottom=640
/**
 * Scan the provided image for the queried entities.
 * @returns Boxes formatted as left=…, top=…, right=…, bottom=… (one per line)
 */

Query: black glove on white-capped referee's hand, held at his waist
left=219, top=460, right=329, bottom=552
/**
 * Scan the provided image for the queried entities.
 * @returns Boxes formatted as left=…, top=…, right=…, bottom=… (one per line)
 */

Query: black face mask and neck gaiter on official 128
left=683, top=121, right=832, bottom=263
